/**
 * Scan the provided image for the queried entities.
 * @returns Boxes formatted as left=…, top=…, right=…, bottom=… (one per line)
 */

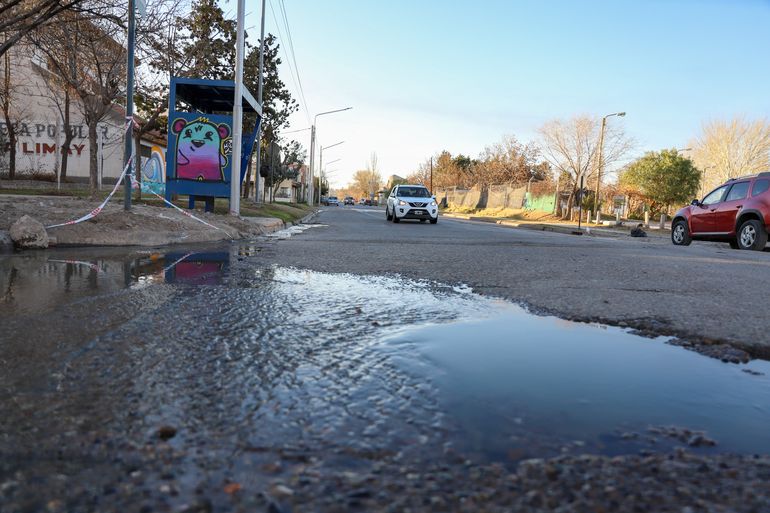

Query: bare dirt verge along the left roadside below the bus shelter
left=0, top=195, right=310, bottom=246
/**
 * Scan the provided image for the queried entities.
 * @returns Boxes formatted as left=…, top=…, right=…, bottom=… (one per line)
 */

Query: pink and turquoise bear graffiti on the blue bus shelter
left=171, top=117, right=230, bottom=182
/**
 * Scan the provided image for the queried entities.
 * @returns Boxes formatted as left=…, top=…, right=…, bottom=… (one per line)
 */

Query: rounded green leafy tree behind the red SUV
left=619, top=149, right=700, bottom=212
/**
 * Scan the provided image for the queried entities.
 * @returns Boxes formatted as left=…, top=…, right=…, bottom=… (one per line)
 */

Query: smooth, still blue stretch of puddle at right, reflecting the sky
left=383, top=314, right=770, bottom=460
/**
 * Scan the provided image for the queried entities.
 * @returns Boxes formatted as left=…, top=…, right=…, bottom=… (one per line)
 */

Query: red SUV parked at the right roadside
left=671, top=172, right=770, bottom=251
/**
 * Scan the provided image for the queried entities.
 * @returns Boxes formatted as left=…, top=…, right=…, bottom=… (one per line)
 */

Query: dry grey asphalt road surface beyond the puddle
left=271, top=207, right=770, bottom=357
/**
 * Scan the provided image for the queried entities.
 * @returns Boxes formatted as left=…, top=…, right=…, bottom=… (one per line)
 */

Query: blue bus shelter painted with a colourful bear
left=166, top=77, right=262, bottom=212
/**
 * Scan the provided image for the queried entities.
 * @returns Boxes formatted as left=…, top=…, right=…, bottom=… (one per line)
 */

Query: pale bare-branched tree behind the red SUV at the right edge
left=692, top=116, right=770, bottom=192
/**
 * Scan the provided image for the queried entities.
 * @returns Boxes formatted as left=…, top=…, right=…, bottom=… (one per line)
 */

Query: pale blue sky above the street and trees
left=240, top=0, right=770, bottom=187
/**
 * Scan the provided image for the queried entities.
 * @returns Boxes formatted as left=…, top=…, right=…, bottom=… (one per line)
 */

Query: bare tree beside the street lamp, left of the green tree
left=539, top=115, right=633, bottom=215
